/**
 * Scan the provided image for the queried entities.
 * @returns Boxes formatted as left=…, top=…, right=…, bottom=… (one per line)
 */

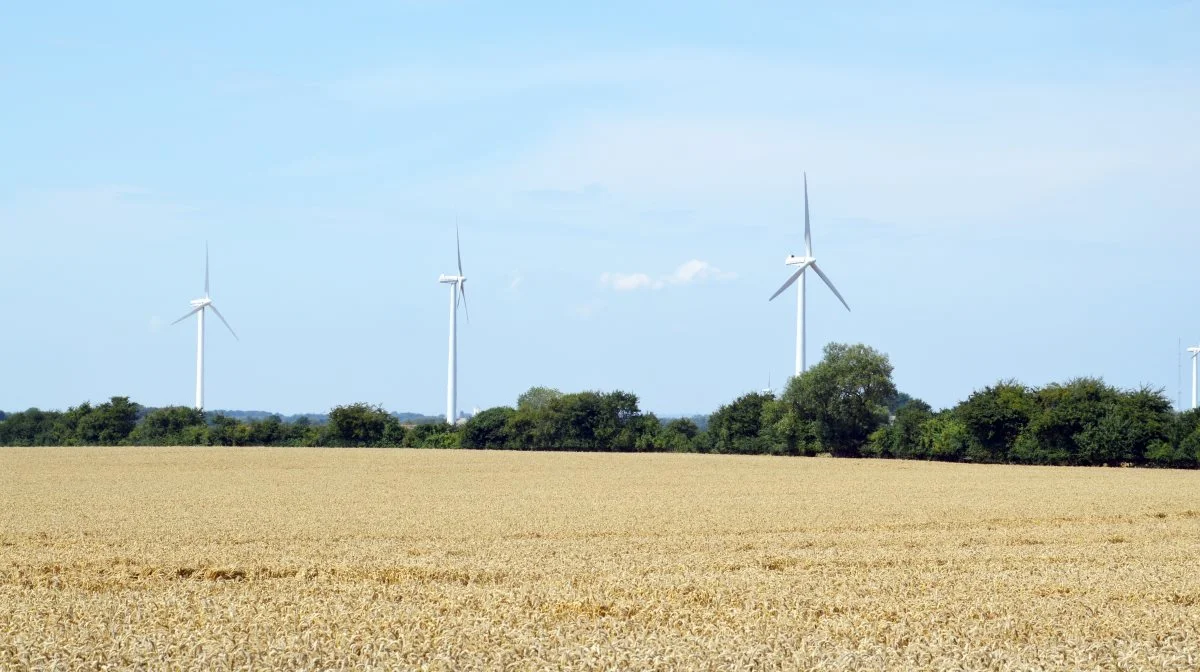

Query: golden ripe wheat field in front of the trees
left=0, top=448, right=1200, bottom=670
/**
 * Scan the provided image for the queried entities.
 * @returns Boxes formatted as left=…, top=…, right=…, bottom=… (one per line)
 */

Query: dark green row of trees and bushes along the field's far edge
left=0, top=343, right=1200, bottom=468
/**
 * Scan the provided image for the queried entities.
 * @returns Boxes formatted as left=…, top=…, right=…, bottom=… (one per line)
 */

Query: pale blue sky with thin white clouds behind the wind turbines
left=0, top=0, right=1200, bottom=414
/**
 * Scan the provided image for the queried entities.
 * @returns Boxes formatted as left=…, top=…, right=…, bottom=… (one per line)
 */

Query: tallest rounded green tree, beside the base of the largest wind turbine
left=782, top=343, right=896, bottom=456
